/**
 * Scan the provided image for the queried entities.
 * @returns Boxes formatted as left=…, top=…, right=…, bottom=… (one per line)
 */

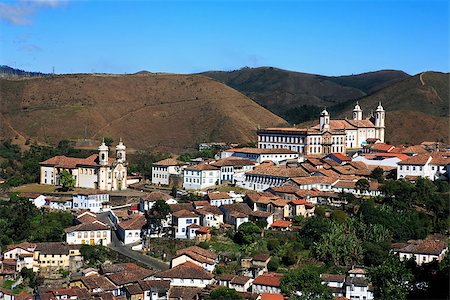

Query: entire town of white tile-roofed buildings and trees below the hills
left=0, top=103, right=450, bottom=300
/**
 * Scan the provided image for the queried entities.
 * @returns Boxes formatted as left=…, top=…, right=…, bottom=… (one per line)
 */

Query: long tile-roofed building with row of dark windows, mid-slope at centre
left=241, top=165, right=308, bottom=191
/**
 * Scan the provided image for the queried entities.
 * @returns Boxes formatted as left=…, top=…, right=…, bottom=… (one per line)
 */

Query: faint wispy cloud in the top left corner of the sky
left=0, top=0, right=67, bottom=25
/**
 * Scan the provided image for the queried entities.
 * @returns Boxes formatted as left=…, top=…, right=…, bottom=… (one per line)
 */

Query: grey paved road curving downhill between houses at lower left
left=97, top=213, right=169, bottom=270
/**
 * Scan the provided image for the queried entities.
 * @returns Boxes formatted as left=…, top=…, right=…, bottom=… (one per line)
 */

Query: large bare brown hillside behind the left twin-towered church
left=0, top=74, right=286, bottom=151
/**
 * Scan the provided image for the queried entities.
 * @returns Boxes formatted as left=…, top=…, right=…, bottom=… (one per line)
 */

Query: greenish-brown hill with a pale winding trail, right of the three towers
left=340, top=72, right=450, bottom=144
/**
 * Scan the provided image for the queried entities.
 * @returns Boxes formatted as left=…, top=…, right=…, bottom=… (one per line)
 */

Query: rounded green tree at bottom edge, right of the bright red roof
left=281, top=267, right=333, bottom=300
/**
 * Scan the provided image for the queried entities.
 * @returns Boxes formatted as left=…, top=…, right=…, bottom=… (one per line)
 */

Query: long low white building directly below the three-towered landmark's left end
left=232, top=148, right=298, bottom=164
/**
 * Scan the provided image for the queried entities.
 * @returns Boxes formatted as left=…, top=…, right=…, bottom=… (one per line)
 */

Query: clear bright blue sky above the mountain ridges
left=0, top=0, right=449, bottom=75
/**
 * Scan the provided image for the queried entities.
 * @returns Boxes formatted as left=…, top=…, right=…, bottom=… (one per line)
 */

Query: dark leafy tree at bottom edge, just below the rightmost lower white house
left=369, top=255, right=413, bottom=300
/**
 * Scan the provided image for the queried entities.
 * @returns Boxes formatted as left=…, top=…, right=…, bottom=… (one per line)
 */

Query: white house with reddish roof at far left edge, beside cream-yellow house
left=2, top=242, right=36, bottom=272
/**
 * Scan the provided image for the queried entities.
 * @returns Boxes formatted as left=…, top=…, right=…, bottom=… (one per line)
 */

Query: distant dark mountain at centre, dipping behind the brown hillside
left=201, top=67, right=409, bottom=124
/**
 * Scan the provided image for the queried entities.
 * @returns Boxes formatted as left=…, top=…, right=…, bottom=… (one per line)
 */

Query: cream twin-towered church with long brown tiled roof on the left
left=40, top=140, right=128, bottom=191
